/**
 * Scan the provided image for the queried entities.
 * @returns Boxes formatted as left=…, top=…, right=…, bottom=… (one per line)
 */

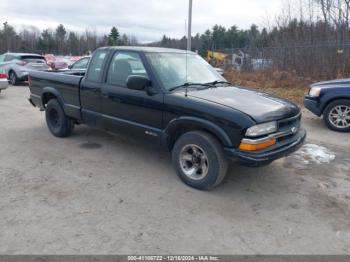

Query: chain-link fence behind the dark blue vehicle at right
left=217, top=43, right=350, bottom=78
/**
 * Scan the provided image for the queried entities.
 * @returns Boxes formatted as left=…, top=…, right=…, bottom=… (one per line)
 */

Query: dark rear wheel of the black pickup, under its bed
left=45, top=99, right=74, bottom=137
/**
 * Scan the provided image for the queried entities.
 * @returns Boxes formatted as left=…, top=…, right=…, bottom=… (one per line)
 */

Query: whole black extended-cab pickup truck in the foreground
left=29, top=47, right=306, bottom=189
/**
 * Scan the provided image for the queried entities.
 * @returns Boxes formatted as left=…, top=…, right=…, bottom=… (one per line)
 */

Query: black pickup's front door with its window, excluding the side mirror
left=101, top=51, right=163, bottom=141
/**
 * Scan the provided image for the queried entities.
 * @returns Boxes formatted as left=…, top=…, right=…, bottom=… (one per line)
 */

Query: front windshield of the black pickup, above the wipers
left=147, top=53, right=225, bottom=90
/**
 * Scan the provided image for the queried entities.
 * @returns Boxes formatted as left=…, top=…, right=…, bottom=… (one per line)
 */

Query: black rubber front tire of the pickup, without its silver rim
left=172, top=131, right=228, bottom=190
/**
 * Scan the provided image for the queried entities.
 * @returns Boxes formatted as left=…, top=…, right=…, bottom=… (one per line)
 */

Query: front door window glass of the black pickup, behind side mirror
left=107, top=52, right=147, bottom=87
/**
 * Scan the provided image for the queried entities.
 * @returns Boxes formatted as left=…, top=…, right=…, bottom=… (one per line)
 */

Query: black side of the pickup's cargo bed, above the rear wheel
left=29, top=71, right=83, bottom=119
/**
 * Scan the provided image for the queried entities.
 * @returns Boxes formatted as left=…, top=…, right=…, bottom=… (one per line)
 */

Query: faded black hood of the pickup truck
left=188, top=86, right=300, bottom=123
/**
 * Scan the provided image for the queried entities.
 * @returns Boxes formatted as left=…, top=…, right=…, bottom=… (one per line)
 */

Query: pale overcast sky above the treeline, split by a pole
left=0, top=0, right=282, bottom=42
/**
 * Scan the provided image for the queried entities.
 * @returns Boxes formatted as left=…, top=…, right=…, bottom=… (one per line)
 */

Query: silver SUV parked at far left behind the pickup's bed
left=0, top=53, right=50, bottom=85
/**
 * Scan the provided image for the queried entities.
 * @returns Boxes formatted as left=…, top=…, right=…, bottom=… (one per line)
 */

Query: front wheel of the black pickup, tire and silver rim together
left=172, top=131, right=228, bottom=190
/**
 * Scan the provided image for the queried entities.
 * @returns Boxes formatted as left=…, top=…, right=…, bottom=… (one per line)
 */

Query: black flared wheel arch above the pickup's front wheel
left=165, top=118, right=232, bottom=151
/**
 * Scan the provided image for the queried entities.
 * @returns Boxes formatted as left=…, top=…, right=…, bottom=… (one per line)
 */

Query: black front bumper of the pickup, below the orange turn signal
left=225, top=129, right=306, bottom=167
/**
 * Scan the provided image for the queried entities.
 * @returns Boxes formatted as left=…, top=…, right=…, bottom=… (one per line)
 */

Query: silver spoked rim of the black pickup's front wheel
left=180, top=144, right=209, bottom=180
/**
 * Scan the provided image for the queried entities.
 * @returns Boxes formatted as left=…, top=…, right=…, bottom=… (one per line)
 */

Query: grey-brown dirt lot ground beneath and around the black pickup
left=0, top=87, right=350, bottom=254
